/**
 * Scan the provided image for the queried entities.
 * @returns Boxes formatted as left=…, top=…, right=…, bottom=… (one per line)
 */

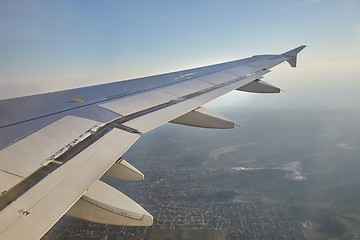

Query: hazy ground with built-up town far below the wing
left=43, top=109, right=360, bottom=240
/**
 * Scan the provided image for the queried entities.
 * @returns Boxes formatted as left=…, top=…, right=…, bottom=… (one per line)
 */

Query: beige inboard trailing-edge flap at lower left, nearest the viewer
left=0, top=129, right=139, bottom=239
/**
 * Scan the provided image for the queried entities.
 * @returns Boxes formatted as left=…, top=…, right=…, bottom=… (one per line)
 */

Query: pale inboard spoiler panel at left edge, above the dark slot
left=0, top=116, right=100, bottom=191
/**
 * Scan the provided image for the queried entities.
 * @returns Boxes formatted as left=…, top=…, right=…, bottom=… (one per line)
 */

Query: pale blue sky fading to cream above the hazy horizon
left=0, top=0, right=360, bottom=108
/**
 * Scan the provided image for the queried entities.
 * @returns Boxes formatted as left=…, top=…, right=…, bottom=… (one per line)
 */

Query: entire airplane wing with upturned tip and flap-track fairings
left=0, top=46, right=305, bottom=239
